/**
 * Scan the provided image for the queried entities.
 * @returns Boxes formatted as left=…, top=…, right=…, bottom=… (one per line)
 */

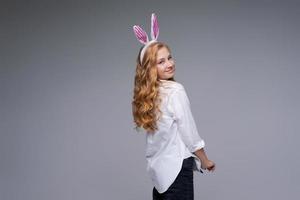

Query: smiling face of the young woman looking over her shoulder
left=156, top=47, right=175, bottom=80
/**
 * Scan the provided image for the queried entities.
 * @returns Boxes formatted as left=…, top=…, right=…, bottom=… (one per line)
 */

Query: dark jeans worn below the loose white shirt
left=152, top=157, right=194, bottom=200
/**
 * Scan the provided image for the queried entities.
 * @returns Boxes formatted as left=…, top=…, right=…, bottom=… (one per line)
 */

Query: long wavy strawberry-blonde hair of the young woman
left=132, top=42, right=175, bottom=133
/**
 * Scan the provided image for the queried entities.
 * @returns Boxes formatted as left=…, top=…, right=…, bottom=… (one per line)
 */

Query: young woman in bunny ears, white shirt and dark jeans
left=132, top=14, right=215, bottom=200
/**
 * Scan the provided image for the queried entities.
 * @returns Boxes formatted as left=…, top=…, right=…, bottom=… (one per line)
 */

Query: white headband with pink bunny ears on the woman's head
left=133, top=13, right=159, bottom=63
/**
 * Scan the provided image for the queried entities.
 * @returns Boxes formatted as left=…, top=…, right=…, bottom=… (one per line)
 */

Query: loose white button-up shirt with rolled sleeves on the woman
left=137, top=80, right=205, bottom=193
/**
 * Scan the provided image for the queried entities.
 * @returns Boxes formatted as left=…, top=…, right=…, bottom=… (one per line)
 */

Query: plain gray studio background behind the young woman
left=0, top=0, right=300, bottom=200
